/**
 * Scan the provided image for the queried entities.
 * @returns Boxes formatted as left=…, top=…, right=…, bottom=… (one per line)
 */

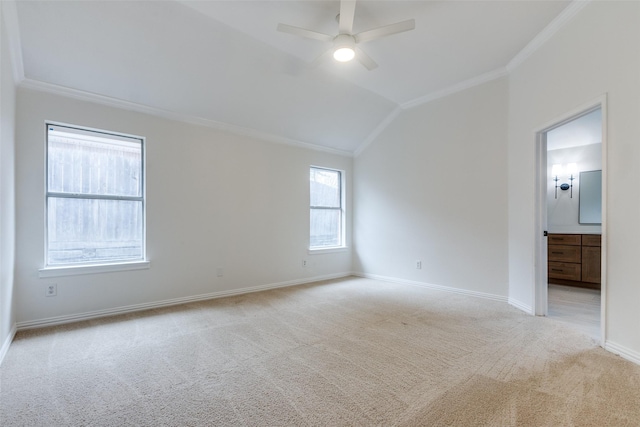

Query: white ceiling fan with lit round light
left=278, top=0, right=416, bottom=71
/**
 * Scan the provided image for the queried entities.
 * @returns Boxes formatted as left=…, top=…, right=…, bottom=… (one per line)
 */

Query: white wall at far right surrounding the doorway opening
left=508, top=1, right=640, bottom=361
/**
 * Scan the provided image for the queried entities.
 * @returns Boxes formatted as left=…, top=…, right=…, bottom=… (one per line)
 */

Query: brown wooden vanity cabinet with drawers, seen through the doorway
left=547, top=234, right=601, bottom=289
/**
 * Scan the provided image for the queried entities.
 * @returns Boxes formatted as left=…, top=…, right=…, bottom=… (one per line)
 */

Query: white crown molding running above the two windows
left=19, top=79, right=353, bottom=157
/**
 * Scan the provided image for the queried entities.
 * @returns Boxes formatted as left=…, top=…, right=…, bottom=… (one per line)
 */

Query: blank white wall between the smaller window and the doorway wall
left=354, top=79, right=508, bottom=298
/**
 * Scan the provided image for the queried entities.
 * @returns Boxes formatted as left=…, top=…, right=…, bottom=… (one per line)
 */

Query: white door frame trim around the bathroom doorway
left=534, top=93, right=608, bottom=346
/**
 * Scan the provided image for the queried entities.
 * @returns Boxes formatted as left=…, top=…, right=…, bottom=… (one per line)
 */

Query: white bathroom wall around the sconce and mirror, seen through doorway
left=547, top=144, right=602, bottom=234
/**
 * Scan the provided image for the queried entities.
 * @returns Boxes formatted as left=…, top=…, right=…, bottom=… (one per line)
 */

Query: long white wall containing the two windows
left=16, top=89, right=352, bottom=326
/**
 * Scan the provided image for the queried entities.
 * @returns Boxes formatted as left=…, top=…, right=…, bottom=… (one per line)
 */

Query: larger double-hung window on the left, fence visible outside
left=45, top=124, right=145, bottom=267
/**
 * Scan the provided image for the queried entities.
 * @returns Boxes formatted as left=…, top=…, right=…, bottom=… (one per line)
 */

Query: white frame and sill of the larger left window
left=39, top=120, right=150, bottom=277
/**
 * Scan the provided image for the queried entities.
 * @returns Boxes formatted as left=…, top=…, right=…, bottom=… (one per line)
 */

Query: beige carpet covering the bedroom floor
left=0, top=278, right=640, bottom=426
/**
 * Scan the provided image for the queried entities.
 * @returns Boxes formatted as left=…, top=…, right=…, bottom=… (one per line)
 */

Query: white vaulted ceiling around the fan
left=11, top=0, right=569, bottom=153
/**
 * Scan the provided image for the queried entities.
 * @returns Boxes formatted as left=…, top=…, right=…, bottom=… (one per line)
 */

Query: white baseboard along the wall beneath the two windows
left=15, top=272, right=352, bottom=332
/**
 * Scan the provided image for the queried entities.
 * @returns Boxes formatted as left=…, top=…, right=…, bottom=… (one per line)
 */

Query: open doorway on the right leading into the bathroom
left=535, top=97, right=606, bottom=343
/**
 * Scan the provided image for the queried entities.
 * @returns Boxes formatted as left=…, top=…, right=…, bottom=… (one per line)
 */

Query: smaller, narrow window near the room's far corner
left=309, top=167, right=344, bottom=249
